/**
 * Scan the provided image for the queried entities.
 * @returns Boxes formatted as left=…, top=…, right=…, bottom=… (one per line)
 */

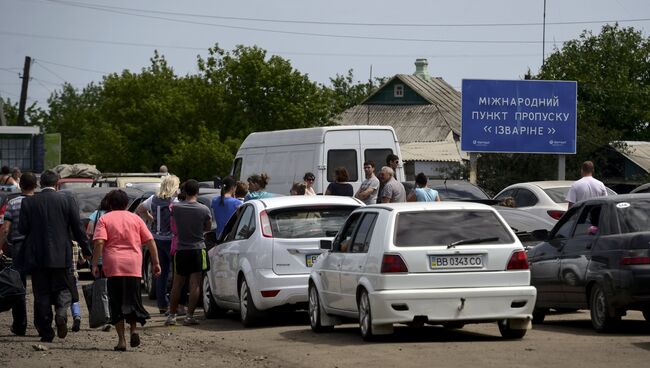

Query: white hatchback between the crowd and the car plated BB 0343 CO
left=203, top=196, right=363, bottom=326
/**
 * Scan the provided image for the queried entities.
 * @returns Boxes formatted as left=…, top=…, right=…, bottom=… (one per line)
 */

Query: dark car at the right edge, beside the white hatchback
left=528, top=194, right=650, bottom=331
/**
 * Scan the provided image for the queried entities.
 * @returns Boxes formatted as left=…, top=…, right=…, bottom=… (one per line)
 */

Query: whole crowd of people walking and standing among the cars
left=0, top=154, right=607, bottom=351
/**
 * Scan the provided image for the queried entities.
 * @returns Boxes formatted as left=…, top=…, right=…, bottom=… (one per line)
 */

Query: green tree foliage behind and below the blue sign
left=478, top=25, right=650, bottom=192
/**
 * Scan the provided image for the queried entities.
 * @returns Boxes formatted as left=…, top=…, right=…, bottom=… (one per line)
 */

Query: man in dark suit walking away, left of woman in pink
left=16, top=170, right=91, bottom=342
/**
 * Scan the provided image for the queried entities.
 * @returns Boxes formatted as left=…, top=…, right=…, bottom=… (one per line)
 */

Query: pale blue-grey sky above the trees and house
left=0, top=0, right=650, bottom=107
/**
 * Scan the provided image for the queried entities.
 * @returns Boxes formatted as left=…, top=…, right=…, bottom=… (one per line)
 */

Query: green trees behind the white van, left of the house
left=36, top=45, right=365, bottom=179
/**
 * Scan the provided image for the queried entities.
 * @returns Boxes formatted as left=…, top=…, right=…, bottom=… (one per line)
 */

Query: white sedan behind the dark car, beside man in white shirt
left=494, top=180, right=616, bottom=221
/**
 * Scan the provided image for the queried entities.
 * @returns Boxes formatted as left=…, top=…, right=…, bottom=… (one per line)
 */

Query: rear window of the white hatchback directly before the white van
left=268, top=206, right=356, bottom=238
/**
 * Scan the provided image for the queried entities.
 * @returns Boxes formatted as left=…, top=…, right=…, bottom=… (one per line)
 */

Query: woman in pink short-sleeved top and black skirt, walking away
left=93, top=189, right=160, bottom=351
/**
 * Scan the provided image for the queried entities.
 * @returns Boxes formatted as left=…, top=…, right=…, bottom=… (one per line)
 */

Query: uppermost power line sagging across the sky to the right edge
left=44, top=0, right=650, bottom=27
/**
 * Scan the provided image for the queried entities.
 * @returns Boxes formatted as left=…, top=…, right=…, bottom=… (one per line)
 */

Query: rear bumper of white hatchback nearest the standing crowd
left=251, top=269, right=309, bottom=310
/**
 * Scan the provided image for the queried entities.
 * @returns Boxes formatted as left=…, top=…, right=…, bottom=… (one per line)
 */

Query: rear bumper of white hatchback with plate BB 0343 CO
left=369, top=286, right=537, bottom=324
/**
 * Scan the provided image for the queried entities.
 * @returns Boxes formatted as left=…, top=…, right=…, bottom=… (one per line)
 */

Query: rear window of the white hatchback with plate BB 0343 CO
left=395, top=210, right=514, bottom=247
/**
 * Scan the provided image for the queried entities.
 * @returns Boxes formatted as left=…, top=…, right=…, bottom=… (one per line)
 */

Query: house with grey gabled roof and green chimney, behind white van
left=337, top=59, right=469, bottom=180
